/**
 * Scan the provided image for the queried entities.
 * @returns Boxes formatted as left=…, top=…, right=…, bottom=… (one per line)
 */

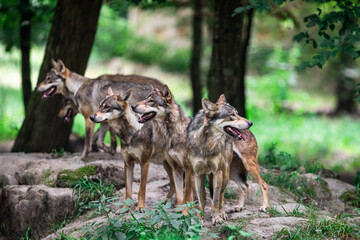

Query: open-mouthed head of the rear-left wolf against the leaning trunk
left=35, top=59, right=69, bottom=99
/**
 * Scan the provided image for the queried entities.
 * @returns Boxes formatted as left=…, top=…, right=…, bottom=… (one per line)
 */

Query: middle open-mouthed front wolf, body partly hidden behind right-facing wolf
left=134, top=85, right=269, bottom=219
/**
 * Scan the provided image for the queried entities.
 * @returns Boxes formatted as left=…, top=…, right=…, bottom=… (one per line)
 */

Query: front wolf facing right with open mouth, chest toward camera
left=187, top=95, right=252, bottom=225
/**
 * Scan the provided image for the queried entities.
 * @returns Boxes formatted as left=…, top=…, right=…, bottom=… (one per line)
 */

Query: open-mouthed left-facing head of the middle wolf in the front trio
left=133, top=85, right=175, bottom=123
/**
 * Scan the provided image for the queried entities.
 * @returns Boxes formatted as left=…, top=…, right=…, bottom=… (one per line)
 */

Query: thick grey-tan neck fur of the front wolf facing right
left=188, top=110, right=231, bottom=157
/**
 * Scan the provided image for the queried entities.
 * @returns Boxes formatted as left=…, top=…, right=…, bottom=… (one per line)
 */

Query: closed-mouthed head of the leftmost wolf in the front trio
left=90, top=88, right=132, bottom=123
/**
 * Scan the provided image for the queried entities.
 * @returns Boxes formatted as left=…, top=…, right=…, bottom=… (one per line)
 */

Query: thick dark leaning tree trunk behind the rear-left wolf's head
left=12, top=0, right=102, bottom=152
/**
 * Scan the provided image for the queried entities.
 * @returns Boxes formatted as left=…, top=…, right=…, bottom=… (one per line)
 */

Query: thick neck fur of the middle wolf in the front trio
left=153, top=103, right=190, bottom=149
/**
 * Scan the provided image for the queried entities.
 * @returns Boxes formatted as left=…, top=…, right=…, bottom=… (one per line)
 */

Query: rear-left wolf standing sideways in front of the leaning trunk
left=36, top=60, right=162, bottom=158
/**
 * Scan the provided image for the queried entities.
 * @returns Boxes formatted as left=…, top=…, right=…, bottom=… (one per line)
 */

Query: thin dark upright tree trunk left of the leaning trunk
left=20, top=0, right=32, bottom=112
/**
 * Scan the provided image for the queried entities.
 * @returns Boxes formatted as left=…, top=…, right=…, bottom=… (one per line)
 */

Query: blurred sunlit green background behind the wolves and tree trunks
left=0, top=0, right=360, bottom=178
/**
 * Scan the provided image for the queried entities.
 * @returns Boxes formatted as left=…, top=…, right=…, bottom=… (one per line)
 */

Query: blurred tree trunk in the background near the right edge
left=335, top=52, right=356, bottom=114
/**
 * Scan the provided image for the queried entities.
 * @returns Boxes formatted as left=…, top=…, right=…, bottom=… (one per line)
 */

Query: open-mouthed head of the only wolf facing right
left=202, top=94, right=253, bottom=140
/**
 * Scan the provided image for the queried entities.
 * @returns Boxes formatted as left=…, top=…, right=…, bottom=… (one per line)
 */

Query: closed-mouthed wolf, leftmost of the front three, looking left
left=91, top=88, right=167, bottom=211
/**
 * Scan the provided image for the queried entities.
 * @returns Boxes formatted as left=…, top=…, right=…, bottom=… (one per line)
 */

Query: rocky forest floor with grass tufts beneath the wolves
left=0, top=152, right=360, bottom=239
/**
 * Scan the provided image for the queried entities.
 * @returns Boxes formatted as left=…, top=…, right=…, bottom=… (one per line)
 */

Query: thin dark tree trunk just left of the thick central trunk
left=190, top=0, right=203, bottom=115
